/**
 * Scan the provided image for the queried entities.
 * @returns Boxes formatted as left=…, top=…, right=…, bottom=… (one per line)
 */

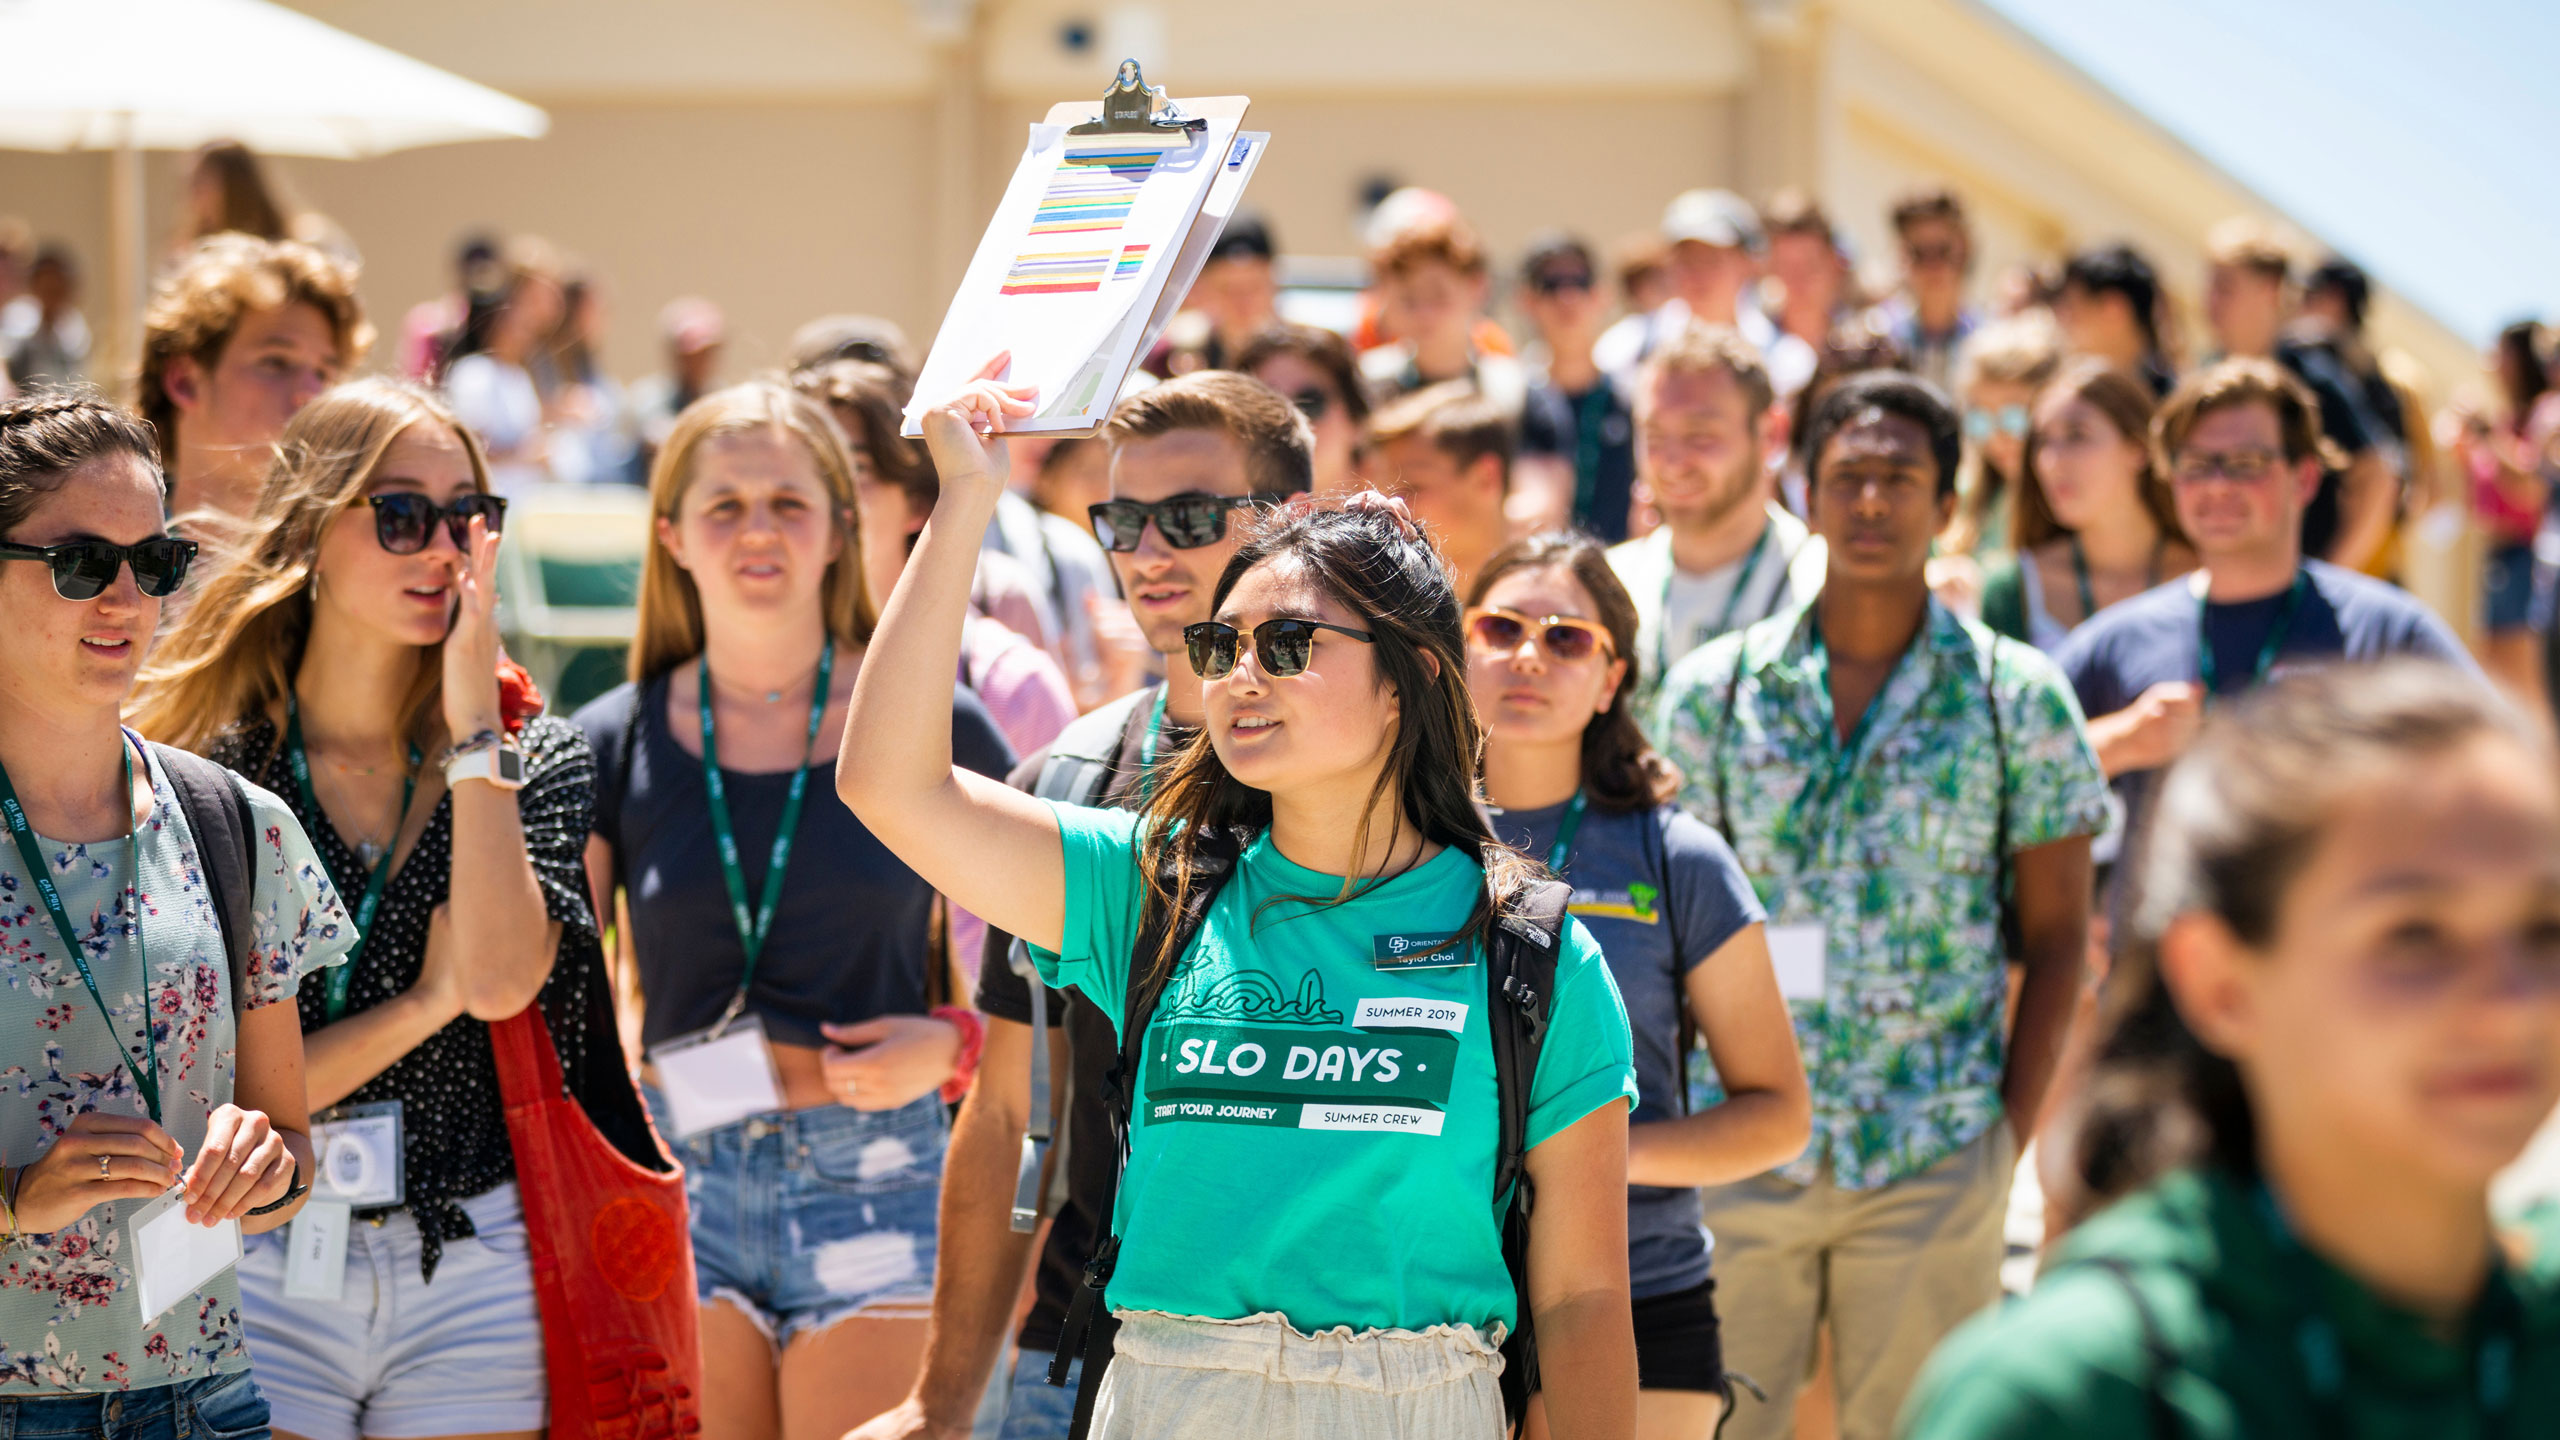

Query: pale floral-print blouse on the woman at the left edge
left=0, top=732, right=356, bottom=1399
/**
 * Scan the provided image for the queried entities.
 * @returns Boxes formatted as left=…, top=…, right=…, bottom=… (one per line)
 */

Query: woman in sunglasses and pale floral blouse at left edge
left=0, top=395, right=353, bottom=1440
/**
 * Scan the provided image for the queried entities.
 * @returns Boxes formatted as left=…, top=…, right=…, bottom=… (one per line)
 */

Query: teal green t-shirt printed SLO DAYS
left=1034, top=805, right=1636, bottom=1332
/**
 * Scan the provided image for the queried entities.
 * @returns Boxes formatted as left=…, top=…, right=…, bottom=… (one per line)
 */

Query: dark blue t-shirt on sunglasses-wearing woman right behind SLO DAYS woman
left=1492, top=789, right=1766, bottom=1299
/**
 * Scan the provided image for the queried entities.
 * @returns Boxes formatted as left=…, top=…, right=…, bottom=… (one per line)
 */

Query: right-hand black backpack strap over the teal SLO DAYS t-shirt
left=1485, top=879, right=1574, bottom=1427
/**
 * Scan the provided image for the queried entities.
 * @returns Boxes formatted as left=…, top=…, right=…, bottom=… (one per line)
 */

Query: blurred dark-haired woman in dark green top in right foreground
left=1900, top=661, right=2560, bottom=1440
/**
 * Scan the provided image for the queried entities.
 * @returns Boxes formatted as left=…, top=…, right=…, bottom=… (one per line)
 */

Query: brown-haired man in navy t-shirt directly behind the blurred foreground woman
left=2053, top=359, right=2476, bottom=899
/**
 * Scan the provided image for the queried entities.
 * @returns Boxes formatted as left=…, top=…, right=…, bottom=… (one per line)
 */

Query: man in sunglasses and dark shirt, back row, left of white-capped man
left=1510, top=233, right=1636, bottom=546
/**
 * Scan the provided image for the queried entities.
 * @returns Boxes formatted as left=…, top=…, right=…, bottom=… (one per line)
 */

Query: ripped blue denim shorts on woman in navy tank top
left=643, top=1089, right=950, bottom=1345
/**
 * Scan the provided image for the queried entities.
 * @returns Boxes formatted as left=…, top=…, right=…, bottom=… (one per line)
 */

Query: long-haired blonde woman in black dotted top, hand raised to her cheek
left=138, top=379, right=666, bottom=1440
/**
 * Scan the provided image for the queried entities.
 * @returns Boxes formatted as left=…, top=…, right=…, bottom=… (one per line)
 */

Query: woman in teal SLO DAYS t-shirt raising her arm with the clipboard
left=837, top=359, right=1636, bottom=1440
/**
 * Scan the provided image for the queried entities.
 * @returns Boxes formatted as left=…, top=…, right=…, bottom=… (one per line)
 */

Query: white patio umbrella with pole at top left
left=0, top=0, right=550, bottom=376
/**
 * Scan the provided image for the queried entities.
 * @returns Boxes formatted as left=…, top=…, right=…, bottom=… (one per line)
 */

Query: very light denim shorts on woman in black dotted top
left=241, top=1181, right=550, bottom=1440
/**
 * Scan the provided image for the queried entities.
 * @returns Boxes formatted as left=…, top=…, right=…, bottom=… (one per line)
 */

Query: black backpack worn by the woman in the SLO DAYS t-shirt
left=1034, top=835, right=1572, bottom=1440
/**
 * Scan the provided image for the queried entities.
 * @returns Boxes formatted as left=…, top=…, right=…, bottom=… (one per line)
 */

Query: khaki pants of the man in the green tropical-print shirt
left=1705, top=1117, right=2017, bottom=1440
